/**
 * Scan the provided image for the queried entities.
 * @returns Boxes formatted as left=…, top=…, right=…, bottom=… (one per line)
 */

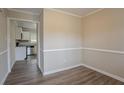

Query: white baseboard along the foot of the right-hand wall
left=81, top=64, right=124, bottom=82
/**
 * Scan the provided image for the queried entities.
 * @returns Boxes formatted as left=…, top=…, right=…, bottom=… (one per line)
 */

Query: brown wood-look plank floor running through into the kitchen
left=4, top=61, right=124, bottom=85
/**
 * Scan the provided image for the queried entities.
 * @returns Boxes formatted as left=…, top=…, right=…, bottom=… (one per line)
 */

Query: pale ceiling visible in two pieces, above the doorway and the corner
left=9, top=8, right=100, bottom=16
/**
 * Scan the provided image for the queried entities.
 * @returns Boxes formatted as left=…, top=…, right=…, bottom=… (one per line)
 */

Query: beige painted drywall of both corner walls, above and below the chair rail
left=43, top=9, right=124, bottom=78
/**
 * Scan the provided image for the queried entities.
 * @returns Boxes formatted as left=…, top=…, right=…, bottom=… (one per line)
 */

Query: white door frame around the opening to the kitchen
left=7, top=17, right=42, bottom=72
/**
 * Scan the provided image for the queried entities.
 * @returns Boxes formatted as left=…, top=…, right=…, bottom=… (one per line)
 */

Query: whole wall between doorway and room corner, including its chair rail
left=43, top=9, right=83, bottom=73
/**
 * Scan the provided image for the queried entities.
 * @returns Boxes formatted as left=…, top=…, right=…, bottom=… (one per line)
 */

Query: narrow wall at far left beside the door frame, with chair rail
left=0, top=9, right=8, bottom=84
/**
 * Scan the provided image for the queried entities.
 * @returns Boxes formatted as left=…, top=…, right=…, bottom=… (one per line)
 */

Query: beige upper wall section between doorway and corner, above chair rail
left=44, top=9, right=82, bottom=49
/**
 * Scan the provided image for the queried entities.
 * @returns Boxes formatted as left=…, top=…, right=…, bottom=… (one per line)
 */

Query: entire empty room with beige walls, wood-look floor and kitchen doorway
left=0, top=8, right=124, bottom=85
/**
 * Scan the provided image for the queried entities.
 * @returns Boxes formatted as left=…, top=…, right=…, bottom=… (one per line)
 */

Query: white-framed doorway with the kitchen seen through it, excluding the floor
left=7, top=18, right=42, bottom=72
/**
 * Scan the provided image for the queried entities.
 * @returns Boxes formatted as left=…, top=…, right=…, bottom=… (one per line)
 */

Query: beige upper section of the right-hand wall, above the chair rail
left=83, top=9, right=124, bottom=51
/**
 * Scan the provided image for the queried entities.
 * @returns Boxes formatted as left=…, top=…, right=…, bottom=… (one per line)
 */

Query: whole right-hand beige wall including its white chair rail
left=82, top=9, right=124, bottom=78
